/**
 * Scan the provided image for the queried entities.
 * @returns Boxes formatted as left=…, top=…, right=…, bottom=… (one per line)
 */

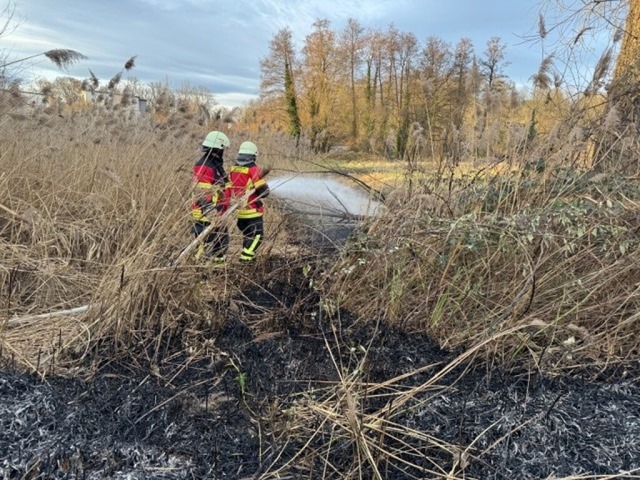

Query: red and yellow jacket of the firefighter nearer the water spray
left=225, top=162, right=269, bottom=218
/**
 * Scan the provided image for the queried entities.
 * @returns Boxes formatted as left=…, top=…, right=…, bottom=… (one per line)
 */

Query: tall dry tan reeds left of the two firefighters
left=0, top=103, right=300, bottom=369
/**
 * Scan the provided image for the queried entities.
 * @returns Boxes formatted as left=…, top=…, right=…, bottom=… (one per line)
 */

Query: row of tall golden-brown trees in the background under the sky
left=247, top=19, right=549, bottom=158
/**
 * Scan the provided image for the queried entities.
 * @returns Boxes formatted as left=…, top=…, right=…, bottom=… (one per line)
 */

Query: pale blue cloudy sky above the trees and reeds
left=0, top=0, right=616, bottom=107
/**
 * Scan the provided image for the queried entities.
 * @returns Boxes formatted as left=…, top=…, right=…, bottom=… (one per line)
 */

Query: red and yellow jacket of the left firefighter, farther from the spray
left=191, top=151, right=227, bottom=222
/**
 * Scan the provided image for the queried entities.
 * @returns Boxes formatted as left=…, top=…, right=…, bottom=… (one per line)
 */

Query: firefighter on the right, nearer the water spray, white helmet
left=225, top=142, right=269, bottom=261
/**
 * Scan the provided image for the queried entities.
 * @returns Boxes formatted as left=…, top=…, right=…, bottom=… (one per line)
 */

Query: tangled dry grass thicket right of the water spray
left=324, top=153, right=640, bottom=371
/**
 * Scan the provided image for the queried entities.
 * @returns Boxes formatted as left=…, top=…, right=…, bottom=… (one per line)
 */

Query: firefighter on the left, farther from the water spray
left=191, top=131, right=229, bottom=262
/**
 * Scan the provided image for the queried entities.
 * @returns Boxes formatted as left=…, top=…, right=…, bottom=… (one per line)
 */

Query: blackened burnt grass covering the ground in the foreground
left=0, top=235, right=640, bottom=479
